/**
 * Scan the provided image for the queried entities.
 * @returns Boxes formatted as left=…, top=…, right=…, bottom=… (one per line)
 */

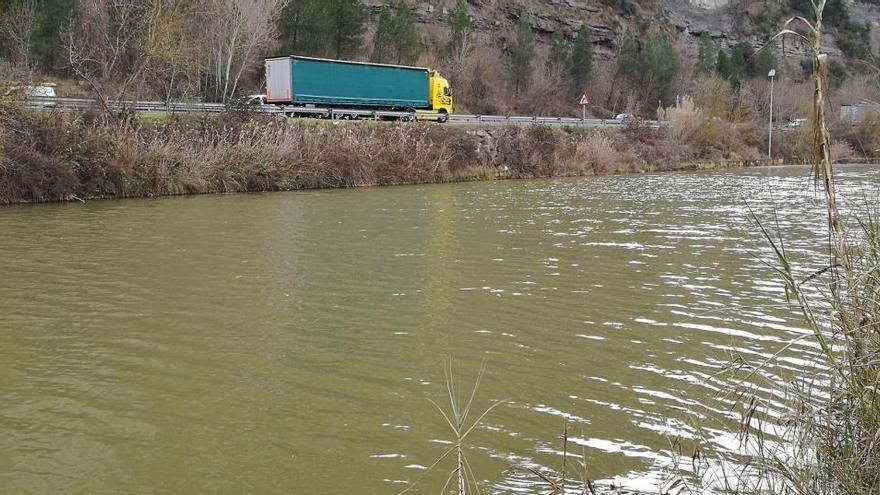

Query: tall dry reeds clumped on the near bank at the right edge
left=680, top=0, right=880, bottom=495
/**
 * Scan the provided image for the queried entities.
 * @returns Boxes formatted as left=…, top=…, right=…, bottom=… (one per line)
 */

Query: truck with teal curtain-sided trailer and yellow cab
left=265, top=56, right=452, bottom=122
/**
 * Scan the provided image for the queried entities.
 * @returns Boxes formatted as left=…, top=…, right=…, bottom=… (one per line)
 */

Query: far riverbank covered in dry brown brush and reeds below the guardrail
left=0, top=109, right=868, bottom=204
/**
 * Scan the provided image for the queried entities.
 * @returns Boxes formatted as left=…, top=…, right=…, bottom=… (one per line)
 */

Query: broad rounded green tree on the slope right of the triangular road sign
left=617, top=33, right=678, bottom=103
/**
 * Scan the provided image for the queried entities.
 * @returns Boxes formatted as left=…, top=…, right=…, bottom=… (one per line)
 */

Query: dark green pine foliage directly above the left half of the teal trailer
left=276, top=0, right=369, bottom=58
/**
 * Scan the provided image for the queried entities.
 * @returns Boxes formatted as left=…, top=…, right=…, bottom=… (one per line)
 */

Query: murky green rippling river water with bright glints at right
left=0, top=167, right=880, bottom=495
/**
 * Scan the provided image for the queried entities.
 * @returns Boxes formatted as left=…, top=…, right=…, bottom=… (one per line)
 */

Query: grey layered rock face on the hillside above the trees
left=363, top=0, right=871, bottom=66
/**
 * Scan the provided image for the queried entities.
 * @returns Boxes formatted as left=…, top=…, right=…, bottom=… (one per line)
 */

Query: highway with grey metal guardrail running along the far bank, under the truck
left=26, top=97, right=663, bottom=128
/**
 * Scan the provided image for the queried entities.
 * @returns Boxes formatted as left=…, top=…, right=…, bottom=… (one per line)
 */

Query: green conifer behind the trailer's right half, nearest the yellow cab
left=371, top=0, right=422, bottom=64
